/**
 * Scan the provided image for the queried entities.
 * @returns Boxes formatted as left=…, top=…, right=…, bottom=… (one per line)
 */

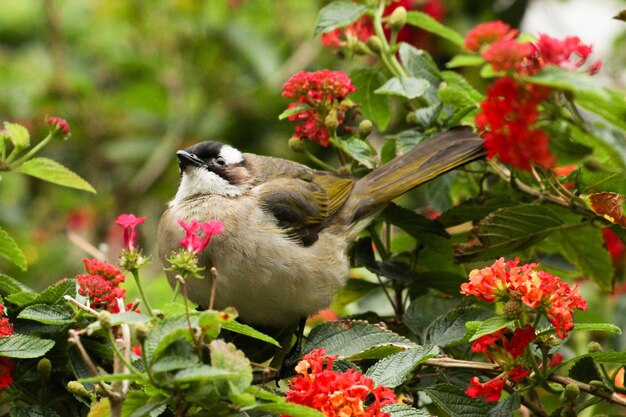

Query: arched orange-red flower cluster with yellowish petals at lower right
left=461, top=258, right=587, bottom=339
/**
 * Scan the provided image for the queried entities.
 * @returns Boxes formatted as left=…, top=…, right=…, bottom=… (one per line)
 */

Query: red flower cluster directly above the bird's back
left=282, top=70, right=355, bottom=146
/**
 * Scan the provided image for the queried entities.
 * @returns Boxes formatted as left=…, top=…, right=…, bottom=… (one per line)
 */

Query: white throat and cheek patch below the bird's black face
left=169, top=167, right=244, bottom=207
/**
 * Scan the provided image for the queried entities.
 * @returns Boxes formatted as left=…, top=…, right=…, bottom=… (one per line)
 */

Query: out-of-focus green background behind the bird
left=0, top=0, right=626, bottom=308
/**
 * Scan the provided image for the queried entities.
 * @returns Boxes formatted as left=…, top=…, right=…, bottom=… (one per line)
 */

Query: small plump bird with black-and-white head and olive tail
left=158, top=128, right=484, bottom=334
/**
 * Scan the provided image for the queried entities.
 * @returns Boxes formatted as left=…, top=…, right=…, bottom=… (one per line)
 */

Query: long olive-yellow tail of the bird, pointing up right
left=337, top=128, right=485, bottom=237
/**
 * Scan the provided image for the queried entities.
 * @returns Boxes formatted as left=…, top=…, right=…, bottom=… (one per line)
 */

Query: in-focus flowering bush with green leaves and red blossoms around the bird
left=0, top=0, right=626, bottom=417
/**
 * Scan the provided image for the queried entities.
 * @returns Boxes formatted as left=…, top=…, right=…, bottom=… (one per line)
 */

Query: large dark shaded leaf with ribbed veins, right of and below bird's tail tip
left=456, top=204, right=584, bottom=262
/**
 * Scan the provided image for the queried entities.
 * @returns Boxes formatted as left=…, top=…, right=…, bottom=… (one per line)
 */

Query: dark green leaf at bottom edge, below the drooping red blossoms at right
left=424, top=384, right=492, bottom=417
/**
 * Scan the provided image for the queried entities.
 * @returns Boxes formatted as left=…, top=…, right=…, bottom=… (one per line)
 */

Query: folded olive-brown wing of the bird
left=252, top=171, right=353, bottom=246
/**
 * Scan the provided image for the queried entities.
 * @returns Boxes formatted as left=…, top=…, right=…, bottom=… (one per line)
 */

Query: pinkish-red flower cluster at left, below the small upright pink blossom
left=76, top=259, right=126, bottom=313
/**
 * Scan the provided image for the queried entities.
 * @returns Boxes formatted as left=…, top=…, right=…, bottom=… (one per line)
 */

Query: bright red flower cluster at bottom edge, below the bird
left=282, top=349, right=396, bottom=417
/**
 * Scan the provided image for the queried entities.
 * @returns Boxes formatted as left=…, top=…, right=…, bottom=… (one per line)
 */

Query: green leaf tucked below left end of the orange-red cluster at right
left=428, top=307, right=494, bottom=346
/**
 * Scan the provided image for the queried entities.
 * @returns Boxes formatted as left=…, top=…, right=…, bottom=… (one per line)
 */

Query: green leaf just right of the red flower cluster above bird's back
left=350, top=69, right=391, bottom=132
